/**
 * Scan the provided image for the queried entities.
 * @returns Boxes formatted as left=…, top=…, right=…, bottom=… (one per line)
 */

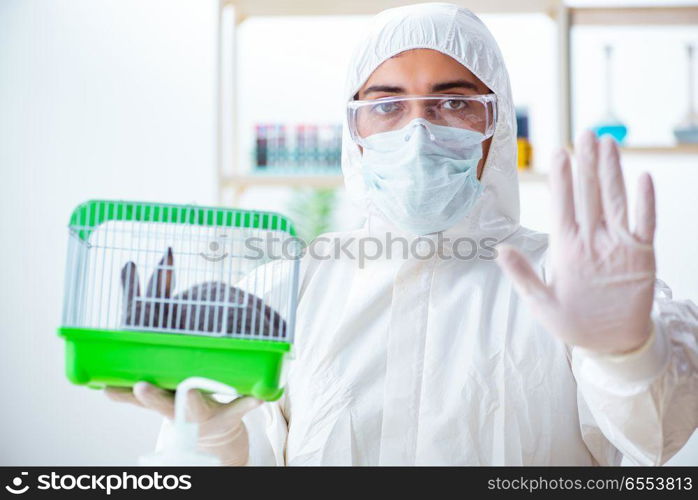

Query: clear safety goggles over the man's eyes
left=347, top=94, right=497, bottom=147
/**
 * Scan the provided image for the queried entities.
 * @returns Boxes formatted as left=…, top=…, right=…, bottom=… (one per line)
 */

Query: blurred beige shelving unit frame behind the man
left=216, top=0, right=698, bottom=205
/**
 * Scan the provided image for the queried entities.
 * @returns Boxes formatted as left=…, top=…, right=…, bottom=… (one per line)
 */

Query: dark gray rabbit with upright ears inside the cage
left=121, top=247, right=286, bottom=338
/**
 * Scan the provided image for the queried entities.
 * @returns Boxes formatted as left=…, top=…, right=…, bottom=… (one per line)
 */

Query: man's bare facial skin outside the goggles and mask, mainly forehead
left=357, top=49, right=492, bottom=179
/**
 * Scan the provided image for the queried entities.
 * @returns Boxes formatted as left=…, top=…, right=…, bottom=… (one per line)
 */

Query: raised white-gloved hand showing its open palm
left=498, top=132, right=655, bottom=354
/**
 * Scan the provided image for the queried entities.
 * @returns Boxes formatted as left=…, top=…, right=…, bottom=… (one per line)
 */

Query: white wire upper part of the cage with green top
left=63, top=200, right=300, bottom=342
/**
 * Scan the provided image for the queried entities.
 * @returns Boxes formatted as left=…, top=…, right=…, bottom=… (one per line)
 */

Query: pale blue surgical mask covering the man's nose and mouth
left=361, top=118, right=484, bottom=235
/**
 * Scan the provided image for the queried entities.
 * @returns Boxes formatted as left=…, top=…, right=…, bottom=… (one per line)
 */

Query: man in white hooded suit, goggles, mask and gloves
left=108, top=3, right=698, bottom=465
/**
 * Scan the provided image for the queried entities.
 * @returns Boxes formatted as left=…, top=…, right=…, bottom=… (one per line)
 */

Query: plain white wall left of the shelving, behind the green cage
left=0, top=0, right=216, bottom=465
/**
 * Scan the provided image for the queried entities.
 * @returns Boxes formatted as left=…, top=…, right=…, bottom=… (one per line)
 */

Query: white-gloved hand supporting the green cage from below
left=104, top=382, right=264, bottom=465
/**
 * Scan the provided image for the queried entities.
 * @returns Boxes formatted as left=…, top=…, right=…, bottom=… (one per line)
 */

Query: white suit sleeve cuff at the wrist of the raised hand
left=574, top=321, right=669, bottom=384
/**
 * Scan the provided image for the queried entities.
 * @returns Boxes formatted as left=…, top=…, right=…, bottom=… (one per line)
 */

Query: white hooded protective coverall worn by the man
left=163, top=3, right=698, bottom=465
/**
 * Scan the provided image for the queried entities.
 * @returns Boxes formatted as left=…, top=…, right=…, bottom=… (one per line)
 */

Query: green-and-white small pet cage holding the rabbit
left=59, top=201, right=299, bottom=400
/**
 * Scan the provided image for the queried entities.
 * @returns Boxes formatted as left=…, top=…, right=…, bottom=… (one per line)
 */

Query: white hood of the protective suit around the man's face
left=342, top=3, right=519, bottom=239
